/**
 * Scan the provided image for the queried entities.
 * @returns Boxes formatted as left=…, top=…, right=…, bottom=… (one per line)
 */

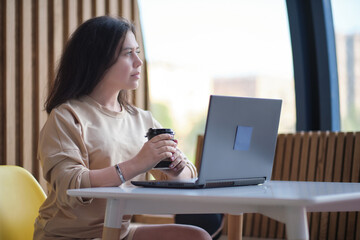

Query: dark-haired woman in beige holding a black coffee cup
left=34, top=16, right=211, bottom=240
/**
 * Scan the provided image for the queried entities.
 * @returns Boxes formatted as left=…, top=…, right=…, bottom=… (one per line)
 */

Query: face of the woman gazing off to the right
left=102, top=31, right=142, bottom=91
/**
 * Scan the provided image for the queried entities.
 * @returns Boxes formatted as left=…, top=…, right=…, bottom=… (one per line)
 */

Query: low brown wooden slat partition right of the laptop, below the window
left=243, top=132, right=360, bottom=240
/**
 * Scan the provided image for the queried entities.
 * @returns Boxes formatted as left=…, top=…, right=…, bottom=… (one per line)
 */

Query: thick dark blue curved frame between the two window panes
left=286, top=0, right=341, bottom=131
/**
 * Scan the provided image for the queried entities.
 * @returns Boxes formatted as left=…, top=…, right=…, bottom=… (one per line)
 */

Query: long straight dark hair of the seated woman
left=44, top=16, right=137, bottom=114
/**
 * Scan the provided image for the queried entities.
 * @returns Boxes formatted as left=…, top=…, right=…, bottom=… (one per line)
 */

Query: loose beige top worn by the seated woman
left=34, top=96, right=196, bottom=239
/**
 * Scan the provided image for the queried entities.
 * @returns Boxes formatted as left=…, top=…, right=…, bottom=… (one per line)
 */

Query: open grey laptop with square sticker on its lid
left=131, top=95, right=282, bottom=188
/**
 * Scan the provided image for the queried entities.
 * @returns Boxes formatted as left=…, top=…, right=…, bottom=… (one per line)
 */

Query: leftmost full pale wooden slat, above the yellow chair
left=3, top=0, right=17, bottom=165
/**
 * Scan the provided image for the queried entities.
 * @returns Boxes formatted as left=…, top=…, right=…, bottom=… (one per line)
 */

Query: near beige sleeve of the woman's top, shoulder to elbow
left=38, top=108, right=91, bottom=207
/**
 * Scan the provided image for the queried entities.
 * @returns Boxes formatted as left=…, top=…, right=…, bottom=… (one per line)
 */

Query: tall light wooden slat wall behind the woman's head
left=0, top=0, right=148, bottom=191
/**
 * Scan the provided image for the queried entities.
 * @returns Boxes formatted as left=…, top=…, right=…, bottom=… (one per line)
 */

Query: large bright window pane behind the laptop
left=139, top=0, right=296, bottom=160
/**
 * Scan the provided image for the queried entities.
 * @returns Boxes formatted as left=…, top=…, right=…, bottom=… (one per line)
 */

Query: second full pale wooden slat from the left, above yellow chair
left=20, top=1, right=35, bottom=173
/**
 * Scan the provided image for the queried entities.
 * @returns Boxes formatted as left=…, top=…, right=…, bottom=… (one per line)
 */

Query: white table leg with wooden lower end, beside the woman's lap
left=102, top=199, right=125, bottom=240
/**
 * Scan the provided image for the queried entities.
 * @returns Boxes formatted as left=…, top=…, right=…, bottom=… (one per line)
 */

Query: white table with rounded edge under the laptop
left=68, top=181, right=360, bottom=239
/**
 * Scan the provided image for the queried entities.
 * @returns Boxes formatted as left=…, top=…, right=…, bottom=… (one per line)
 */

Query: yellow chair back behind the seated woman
left=0, top=165, right=46, bottom=240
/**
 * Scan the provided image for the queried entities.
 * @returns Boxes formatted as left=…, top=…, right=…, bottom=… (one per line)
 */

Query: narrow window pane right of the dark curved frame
left=331, top=0, right=360, bottom=131
